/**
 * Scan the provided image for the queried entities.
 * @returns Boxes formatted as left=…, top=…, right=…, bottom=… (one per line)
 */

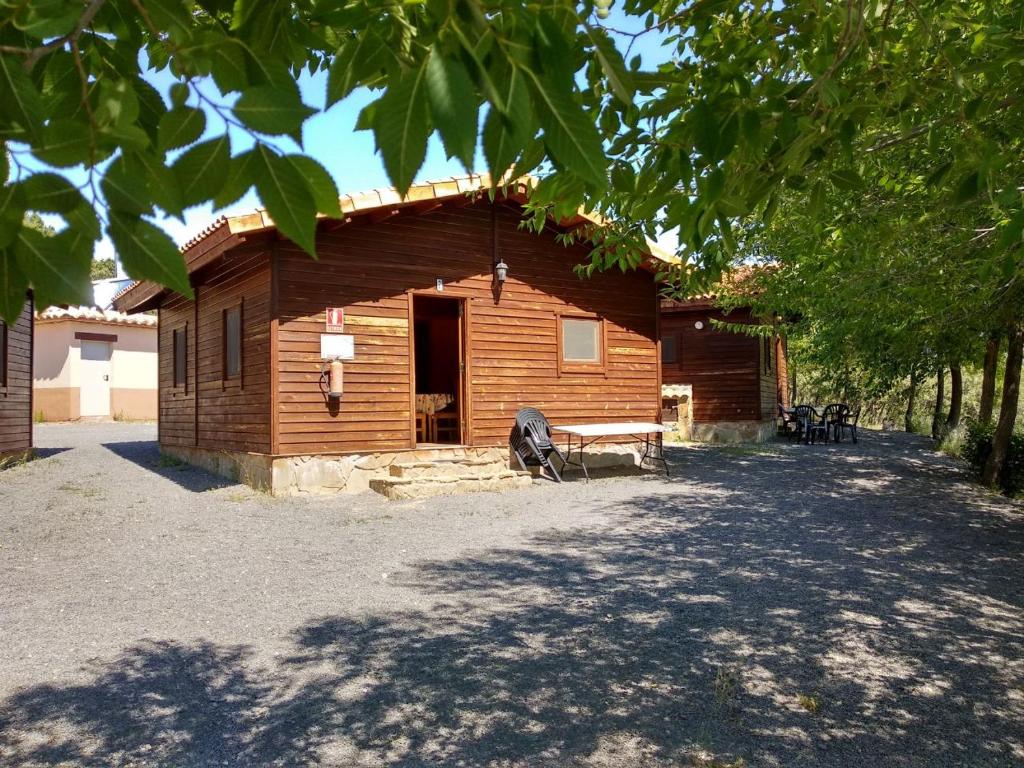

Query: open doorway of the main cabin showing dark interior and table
left=413, top=296, right=466, bottom=446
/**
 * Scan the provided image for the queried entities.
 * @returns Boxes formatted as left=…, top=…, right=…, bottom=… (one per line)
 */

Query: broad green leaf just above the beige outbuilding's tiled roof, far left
left=14, top=226, right=92, bottom=306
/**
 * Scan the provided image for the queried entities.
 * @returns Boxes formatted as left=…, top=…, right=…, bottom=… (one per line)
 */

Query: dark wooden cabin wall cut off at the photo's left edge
left=0, top=297, right=33, bottom=467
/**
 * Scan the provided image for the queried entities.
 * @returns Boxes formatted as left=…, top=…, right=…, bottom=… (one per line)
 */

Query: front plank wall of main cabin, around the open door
left=274, top=202, right=660, bottom=454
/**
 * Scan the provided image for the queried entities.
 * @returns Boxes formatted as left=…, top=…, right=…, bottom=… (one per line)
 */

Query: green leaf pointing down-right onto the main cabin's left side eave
left=106, top=213, right=193, bottom=298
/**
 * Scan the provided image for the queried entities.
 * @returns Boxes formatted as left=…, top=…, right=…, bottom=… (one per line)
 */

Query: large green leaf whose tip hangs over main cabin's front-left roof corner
left=253, top=144, right=316, bottom=258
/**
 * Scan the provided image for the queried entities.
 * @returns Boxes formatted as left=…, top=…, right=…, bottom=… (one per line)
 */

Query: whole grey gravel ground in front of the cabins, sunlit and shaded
left=0, top=424, right=1024, bottom=768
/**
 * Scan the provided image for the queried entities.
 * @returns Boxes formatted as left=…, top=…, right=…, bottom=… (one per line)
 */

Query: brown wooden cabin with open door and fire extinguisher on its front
left=115, top=176, right=660, bottom=494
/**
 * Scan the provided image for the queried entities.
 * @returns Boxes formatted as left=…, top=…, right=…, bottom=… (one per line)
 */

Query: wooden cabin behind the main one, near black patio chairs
left=660, top=296, right=790, bottom=442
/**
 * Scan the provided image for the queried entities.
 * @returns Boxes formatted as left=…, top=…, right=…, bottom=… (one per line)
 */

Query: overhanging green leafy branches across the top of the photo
left=0, top=0, right=1024, bottom=317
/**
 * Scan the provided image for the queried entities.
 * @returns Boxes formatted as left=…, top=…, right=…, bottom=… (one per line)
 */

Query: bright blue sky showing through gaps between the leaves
left=34, top=8, right=667, bottom=274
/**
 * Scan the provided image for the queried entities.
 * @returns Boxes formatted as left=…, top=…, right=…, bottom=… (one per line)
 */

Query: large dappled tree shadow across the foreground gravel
left=0, top=430, right=1024, bottom=768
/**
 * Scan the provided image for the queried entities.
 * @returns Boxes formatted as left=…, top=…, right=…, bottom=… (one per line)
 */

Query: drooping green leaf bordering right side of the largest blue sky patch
left=374, top=65, right=430, bottom=195
